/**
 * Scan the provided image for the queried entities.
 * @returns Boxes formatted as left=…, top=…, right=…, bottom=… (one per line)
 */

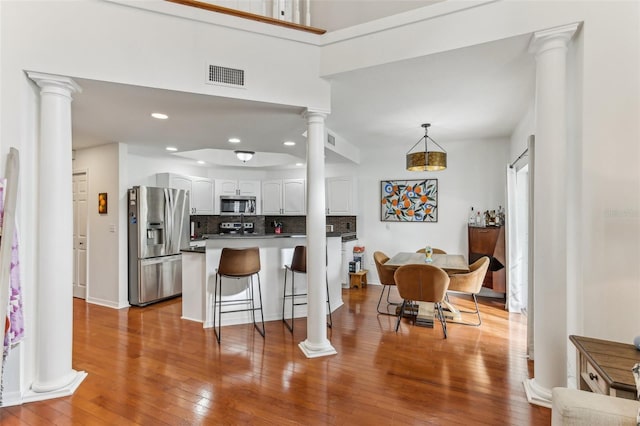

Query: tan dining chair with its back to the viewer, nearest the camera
left=394, top=264, right=449, bottom=339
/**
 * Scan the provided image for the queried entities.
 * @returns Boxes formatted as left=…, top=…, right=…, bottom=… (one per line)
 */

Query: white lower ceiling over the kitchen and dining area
left=72, top=5, right=534, bottom=167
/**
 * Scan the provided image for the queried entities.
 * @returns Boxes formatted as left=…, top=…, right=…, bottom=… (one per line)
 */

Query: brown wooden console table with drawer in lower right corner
left=569, top=336, right=640, bottom=399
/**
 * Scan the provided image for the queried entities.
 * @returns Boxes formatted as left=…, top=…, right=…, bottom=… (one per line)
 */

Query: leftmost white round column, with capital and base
left=26, top=72, right=86, bottom=400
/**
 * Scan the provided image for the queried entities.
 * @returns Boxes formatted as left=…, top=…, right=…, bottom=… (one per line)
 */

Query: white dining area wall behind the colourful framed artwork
left=358, top=139, right=509, bottom=283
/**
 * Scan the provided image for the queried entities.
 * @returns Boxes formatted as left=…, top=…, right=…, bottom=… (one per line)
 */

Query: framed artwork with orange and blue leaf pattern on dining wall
left=380, top=179, right=438, bottom=222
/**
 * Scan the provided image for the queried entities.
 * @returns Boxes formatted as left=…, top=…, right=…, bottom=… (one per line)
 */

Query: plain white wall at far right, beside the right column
left=577, top=2, right=640, bottom=343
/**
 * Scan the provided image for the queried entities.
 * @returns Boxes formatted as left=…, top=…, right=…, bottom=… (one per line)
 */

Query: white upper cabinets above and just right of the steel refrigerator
left=156, top=173, right=214, bottom=215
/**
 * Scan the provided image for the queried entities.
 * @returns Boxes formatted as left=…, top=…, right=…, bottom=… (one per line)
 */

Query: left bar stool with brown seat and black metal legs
left=213, top=247, right=265, bottom=343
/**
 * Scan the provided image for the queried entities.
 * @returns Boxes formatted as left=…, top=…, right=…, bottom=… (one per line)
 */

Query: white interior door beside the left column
left=73, top=172, right=88, bottom=299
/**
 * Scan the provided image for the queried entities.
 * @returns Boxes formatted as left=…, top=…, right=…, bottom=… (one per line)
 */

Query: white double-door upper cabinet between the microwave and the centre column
left=262, top=179, right=306, bottom=216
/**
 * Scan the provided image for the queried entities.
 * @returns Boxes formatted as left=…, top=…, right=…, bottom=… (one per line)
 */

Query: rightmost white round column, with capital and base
left=525, top=23, right=578, bottom=407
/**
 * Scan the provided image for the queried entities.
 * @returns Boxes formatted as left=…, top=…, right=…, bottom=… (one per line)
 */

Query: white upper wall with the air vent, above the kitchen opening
left=2, top=1, right=330, bottom=110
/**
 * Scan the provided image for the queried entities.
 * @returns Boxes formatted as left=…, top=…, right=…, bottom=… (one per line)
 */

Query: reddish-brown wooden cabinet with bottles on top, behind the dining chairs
left=469, top=226, right=506, bottom=293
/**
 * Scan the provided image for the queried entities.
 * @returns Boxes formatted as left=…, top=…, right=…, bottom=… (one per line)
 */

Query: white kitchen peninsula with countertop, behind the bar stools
left=182, top=233, right=343, bottom=328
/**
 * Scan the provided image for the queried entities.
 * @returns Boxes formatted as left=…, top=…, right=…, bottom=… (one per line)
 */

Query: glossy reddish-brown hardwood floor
left=0, top=286, right=551, bottom=425
